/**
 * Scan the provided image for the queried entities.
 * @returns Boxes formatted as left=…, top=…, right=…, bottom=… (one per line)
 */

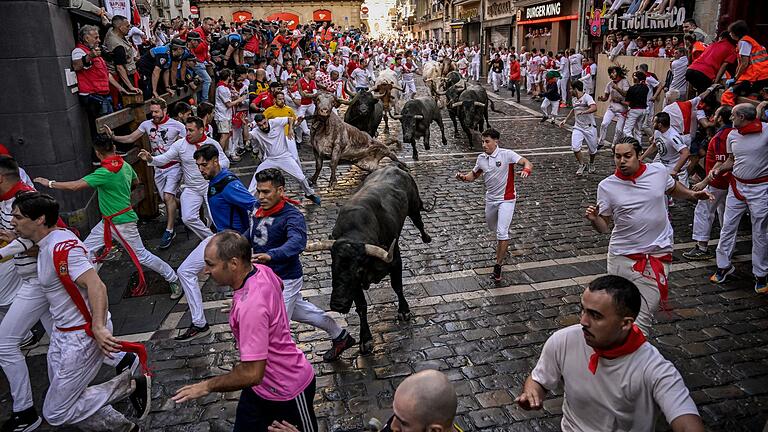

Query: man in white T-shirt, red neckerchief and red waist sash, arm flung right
left=585, top=137, right=714, bottom=334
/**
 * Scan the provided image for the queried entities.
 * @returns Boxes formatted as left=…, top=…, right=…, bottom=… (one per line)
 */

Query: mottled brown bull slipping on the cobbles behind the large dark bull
left=310, top=92, right=402, bottom=187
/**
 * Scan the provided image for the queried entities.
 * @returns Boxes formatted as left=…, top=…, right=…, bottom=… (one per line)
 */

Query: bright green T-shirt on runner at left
left=83, top=163, right=139, bottom=225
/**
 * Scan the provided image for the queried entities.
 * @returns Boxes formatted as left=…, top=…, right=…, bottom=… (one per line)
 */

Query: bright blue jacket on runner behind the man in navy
left=208, top=169, right=259, bottom=233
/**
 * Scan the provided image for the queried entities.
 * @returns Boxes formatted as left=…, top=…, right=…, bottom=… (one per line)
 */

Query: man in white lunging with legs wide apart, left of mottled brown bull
left=248, top=114, right=320, bottom=205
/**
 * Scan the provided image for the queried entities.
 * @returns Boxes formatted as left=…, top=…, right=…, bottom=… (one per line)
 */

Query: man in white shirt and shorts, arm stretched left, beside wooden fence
left=104, top=98, right=187, bottom=249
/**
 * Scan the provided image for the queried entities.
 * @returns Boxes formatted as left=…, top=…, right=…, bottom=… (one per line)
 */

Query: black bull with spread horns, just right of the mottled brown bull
left=389, top=96, right=448, bottom=160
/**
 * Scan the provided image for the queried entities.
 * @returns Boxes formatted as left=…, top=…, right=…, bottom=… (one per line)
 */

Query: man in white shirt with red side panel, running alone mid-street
left=456, top=128, right=533, bottom=282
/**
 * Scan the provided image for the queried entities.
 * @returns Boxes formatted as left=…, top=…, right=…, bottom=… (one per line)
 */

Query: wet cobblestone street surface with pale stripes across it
left=0, top=78, right=768, bottom=432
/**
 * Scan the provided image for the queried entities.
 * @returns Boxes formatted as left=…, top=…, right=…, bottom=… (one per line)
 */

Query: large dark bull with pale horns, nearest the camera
left=305, top=164, right=434, bottom=354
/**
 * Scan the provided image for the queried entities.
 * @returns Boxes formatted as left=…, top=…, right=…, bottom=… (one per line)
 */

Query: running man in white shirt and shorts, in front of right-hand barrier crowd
left=560, top=81, right=597, bottom=175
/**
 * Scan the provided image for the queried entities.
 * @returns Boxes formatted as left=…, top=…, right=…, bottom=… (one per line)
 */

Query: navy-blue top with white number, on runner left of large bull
left=248, top=203, right=307, bottom=280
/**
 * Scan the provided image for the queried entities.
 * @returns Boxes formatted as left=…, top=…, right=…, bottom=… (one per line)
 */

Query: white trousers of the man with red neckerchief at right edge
left=717, top=182, right=768, bottom=277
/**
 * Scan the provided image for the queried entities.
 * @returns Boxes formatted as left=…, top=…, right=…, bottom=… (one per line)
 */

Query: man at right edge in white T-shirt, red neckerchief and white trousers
left=710, top=103, right=768, bottom=294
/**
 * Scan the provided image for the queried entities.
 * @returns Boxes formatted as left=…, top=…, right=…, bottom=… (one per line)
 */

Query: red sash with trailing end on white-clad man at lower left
left=53, top=240, right=151, bottom=374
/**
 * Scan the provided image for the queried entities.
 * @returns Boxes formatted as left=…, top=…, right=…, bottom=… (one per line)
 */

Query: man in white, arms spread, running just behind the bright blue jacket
left=138, top=117, right=229, bottom=240
